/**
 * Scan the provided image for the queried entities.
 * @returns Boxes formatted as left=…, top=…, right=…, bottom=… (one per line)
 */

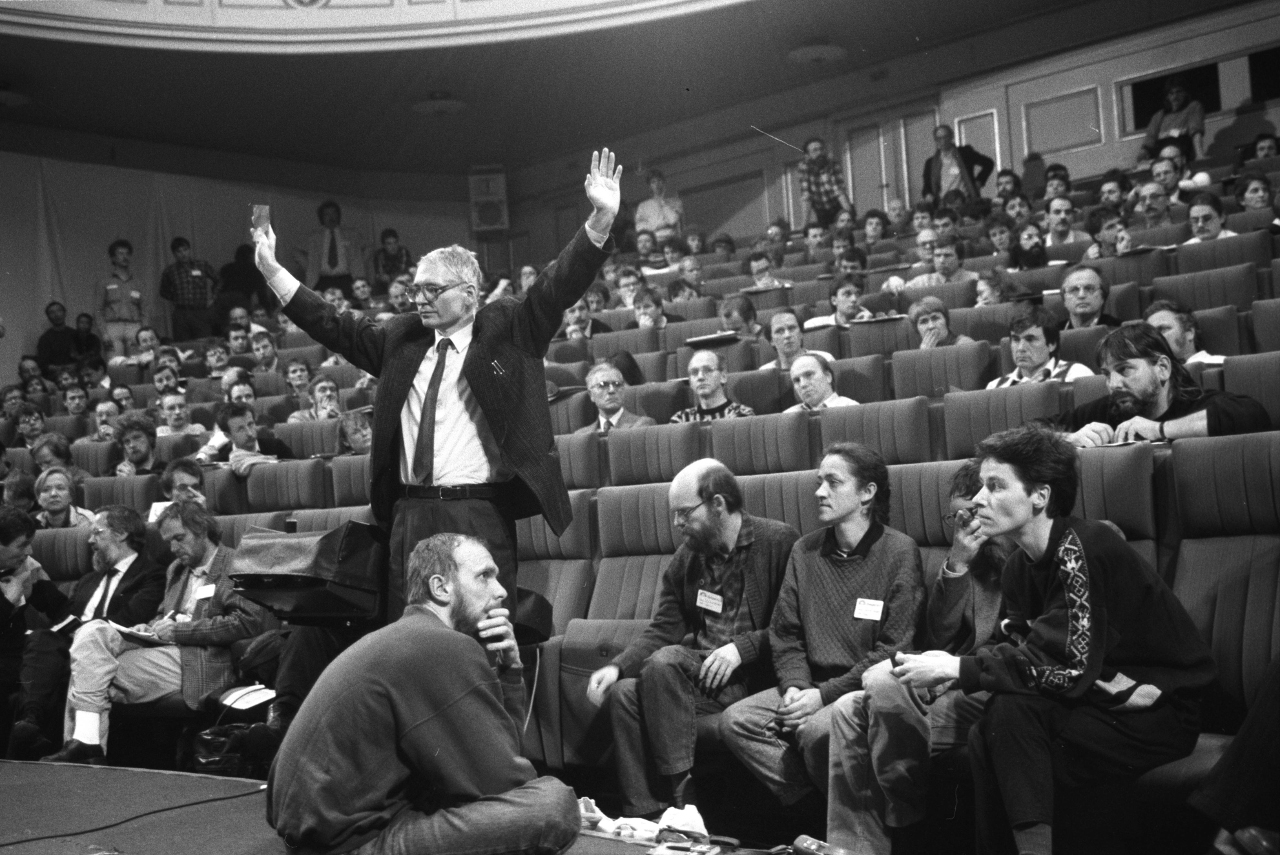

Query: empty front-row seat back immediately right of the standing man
left=516, top=490, right=595, bottom=635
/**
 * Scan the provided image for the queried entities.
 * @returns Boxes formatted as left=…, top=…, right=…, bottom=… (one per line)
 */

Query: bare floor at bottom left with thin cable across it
left=0, top=760, right=645, bottom=855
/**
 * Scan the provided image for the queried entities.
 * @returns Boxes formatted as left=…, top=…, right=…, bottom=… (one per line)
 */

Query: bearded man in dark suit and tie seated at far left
left=10, top=504, right=164, bottom=760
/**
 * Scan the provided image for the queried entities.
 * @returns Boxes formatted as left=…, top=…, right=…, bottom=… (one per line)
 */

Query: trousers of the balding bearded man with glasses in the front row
left=609, top=645, right=746, bottom=817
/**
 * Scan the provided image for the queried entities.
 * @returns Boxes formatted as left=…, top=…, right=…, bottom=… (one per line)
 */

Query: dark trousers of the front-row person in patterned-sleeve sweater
left=969, top=694, right=1198, bottom=854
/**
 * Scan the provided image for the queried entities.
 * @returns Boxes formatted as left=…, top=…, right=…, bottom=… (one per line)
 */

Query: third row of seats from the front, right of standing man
left=550, top=348, right=1280, bottom=434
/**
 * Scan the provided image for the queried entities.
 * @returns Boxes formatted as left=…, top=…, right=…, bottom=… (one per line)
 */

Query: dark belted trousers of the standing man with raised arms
left=387, top=499, right=516, bottom=621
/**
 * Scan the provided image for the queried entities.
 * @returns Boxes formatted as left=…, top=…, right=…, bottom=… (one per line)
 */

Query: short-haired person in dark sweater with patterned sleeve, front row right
left=893, top=424, right=1213, bottom=855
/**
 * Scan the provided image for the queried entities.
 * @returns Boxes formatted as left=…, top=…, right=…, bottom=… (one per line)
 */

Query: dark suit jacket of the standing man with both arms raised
left=284, top=228, right=611, bottom=534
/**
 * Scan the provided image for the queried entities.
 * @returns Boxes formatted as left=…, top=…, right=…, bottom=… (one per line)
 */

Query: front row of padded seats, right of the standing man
left=501, top=433, right=1280, bottom=797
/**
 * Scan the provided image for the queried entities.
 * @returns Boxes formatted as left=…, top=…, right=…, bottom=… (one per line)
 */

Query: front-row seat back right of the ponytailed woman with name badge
left=888, top=461, right=964, bottom=578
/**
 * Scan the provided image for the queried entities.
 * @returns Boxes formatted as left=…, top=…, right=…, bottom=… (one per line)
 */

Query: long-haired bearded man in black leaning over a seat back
left=1056, top=324, right=1271, bottom=448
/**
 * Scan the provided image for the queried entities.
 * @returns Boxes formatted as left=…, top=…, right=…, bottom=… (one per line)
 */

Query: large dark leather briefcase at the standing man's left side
left=230, top=521, right=387, bottom=625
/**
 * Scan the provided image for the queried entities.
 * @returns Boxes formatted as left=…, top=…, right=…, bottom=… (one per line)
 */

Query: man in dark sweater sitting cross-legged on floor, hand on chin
left=266, top=534, right=580, bottom=855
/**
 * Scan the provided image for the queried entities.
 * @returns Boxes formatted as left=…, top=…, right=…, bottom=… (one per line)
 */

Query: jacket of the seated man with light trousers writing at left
left=157, top=547, right=279, bottom=709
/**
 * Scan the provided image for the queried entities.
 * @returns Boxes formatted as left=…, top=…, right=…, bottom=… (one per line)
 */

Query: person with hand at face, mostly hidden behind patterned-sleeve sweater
left=827, top=461, right=1014, bottom=855
